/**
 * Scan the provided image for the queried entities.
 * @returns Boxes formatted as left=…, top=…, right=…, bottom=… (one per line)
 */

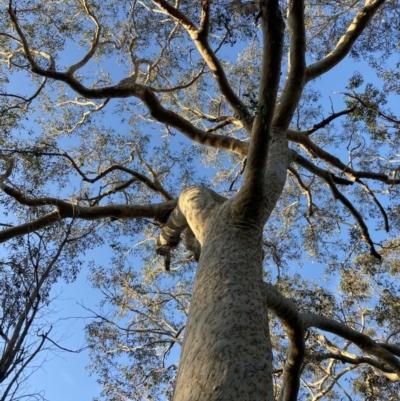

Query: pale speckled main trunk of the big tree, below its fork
left=173, top=197, right=273, bottom=401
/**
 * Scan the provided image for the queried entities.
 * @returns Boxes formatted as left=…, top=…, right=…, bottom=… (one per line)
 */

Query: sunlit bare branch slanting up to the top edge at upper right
left=307, top=0, right=385, bottom=81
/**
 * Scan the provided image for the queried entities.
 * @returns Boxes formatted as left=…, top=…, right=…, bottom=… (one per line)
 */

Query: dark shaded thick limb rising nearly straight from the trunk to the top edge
left=234, top=0, right=286, bottom=220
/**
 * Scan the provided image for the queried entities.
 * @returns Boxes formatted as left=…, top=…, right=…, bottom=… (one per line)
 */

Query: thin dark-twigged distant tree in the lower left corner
left=0, top=224, right=84, bottom=401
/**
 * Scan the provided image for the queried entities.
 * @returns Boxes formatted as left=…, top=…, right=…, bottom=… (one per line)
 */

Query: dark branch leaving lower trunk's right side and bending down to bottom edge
left=264, top=283, right=305, bottom=401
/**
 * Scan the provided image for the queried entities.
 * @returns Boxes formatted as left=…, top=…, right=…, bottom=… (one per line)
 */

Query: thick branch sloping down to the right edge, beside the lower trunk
left=301, top=314, right=400, bottom=378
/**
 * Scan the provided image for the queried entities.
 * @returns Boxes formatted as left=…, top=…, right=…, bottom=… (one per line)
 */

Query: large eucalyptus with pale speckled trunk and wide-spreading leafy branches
left=0, top=0, right=400, bottom=401
